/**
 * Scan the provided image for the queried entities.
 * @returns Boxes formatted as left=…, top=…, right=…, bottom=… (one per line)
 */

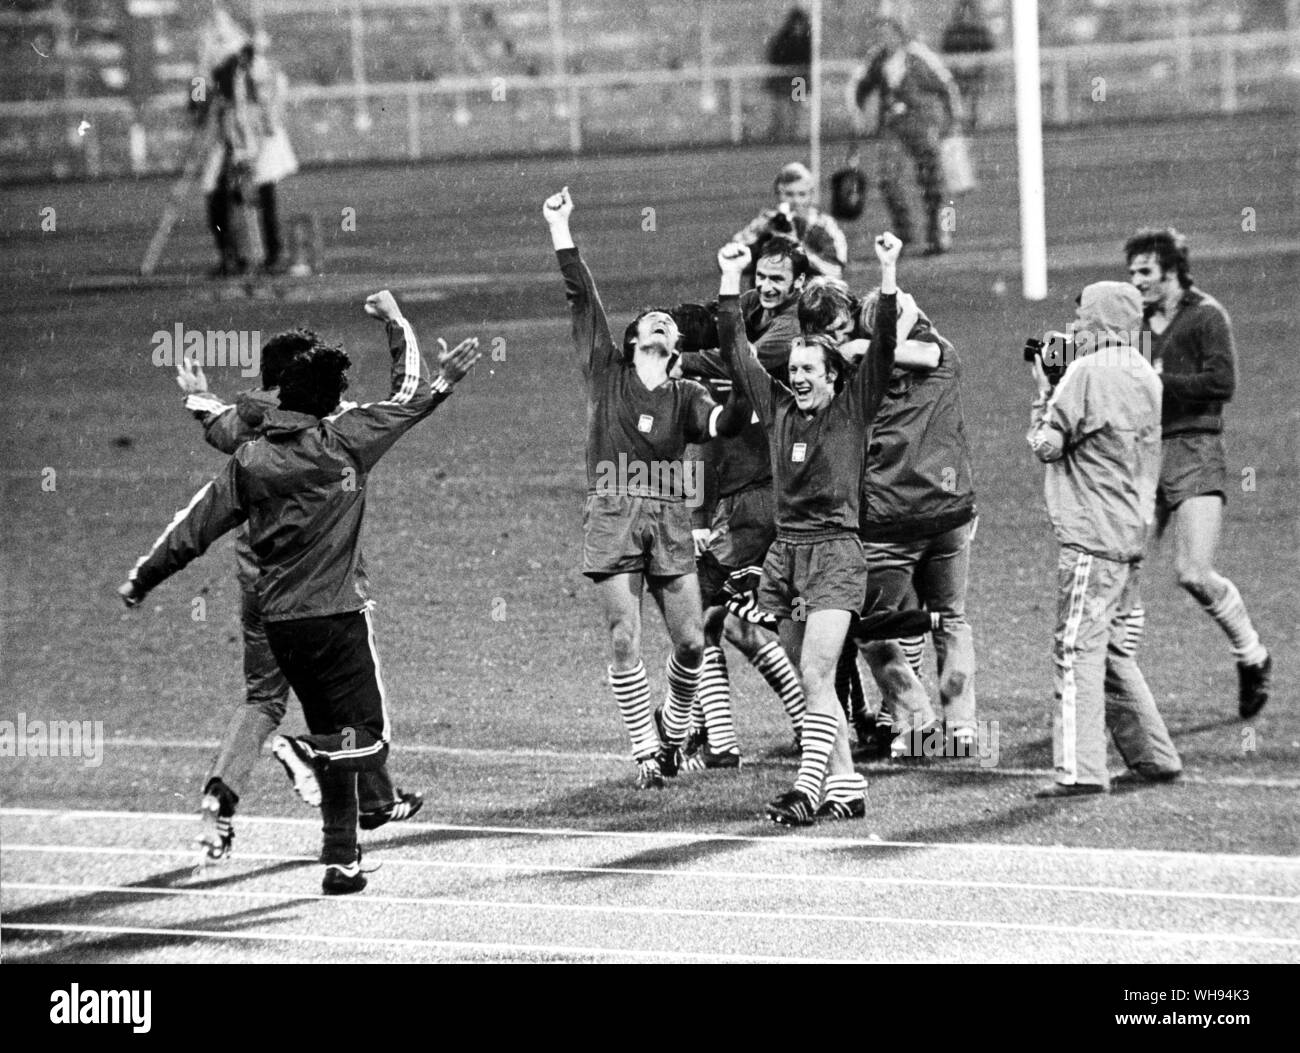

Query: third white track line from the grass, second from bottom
left=5, top=885, right=1300, bottom=946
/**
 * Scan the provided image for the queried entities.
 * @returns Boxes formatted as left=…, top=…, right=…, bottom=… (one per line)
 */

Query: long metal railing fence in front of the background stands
left=0, top=31, right=1300, bottom=179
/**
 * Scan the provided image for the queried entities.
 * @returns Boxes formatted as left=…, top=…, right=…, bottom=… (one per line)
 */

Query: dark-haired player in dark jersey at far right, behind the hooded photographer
left=1125, top=228, right=1273, bottom=719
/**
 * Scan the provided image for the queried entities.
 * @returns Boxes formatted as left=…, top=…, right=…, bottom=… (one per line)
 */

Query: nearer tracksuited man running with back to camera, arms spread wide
left=118, top=291, right=478, bottom=893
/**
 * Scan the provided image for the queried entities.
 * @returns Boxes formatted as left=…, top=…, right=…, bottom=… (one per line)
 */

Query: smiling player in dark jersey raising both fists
left=718, top=234, right=902, bottom=826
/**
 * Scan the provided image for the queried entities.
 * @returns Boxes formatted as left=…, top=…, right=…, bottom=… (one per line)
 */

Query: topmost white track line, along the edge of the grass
left=0, top=807, right=1300, bottom=871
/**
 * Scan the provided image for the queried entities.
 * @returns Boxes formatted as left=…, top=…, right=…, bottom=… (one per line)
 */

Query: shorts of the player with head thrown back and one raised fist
left=582, top=494, right=696, bottom=579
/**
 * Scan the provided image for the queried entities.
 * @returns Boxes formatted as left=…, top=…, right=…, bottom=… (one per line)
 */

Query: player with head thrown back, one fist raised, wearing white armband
left=542, top=187, right=748, bottom=789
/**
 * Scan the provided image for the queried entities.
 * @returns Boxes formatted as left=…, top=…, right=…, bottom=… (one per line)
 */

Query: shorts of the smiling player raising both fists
left=758, top=534, right=867, bottom=620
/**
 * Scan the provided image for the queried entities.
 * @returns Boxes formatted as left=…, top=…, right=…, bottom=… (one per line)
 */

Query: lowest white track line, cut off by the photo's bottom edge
left=0, top=920, right=868, bottom=965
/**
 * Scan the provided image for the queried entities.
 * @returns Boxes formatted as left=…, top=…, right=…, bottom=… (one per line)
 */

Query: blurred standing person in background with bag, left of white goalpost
left=849, top=18, right=963, bottom=256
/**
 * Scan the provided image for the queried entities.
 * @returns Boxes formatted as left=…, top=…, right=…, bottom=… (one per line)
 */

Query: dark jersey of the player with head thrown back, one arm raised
left=556, top=248, right=716, bottom=501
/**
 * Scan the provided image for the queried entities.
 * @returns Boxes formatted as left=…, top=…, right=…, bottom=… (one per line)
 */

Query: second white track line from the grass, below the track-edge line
left=0, top=844, right=1300, bottom=906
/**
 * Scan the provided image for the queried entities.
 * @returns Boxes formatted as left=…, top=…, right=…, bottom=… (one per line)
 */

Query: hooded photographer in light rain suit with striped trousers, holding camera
left=1026, top=282, right=1182, bottom=798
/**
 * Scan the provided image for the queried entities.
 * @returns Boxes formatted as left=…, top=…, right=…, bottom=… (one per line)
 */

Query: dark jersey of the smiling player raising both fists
left=718, top=295, right=898, bottom=538
